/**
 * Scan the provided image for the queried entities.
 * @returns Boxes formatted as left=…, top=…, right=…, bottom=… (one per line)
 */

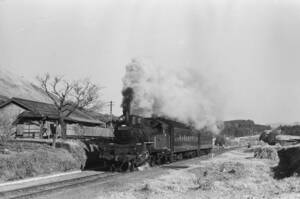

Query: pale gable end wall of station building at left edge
left=0, top=104, right=25, bottom=135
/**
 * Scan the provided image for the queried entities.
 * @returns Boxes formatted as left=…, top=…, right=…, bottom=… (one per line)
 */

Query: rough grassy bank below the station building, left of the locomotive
left=0, top=143, right=82, bottom=181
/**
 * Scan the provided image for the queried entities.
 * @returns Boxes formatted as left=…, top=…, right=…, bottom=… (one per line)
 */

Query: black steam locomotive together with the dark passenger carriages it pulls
left=100, top=113, right=213, bottom=171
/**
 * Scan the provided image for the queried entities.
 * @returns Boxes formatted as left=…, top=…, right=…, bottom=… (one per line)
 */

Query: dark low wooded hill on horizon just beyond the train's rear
left=220, top=120, right=271, bottom=137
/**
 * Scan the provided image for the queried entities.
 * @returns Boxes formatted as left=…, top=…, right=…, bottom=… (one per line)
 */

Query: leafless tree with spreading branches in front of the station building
left=37, top=74, right=102, bottom=139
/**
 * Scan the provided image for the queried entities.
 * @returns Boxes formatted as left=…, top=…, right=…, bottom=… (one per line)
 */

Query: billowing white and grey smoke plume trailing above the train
left=122, top=60, right=220, bottom=132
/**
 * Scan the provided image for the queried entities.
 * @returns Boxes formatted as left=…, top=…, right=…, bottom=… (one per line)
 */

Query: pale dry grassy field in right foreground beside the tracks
left=98, top=150, right=300, bottom=199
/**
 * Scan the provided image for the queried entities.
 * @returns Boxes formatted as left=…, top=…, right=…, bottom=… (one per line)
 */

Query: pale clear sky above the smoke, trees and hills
left=0, top=0, right=300, bottom=123
